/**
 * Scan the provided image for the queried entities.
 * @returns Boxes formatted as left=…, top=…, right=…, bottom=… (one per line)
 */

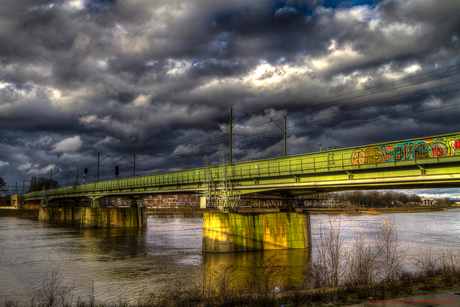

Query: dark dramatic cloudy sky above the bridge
left=0, top=0, right=460, bottom=200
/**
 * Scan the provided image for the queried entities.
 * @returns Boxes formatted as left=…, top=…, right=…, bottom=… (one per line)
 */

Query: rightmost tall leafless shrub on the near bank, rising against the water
left=376, top=218, right=406, bottom=282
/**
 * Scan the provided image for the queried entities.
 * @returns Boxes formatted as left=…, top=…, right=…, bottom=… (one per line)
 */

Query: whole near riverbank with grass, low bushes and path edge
left=3, top=268, right=460, bottom=307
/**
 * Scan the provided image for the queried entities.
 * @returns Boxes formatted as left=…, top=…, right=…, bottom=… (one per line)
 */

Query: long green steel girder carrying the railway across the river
left=25, top=133, right=460, bottom=200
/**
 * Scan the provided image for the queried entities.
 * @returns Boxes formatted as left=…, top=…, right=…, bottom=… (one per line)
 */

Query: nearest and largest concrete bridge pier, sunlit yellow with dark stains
left=202, top=212, right=311, bottom=253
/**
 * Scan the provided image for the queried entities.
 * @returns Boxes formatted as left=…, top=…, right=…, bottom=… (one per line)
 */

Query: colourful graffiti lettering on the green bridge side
left=351, top=136, right=460, bottom=165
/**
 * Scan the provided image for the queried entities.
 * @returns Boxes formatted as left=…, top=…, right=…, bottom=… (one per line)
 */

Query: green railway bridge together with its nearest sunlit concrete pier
left=24, top=133, right=460, bottom=252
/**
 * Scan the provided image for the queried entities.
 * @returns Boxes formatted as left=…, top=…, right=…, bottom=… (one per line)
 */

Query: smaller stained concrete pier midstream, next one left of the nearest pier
left=81, top=207, right=147, bottom=228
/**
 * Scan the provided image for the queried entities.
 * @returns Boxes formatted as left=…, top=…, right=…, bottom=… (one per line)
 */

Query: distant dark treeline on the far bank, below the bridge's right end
left=329, top=191, right=451, bottom=207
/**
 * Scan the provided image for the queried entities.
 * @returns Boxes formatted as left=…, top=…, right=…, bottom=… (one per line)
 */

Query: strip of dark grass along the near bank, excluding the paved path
left=3, top=273, right=460, bottom=307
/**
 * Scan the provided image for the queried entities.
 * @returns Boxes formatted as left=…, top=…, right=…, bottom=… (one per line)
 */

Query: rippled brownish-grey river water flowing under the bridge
left=0, top=209, right=460, bottom=304
